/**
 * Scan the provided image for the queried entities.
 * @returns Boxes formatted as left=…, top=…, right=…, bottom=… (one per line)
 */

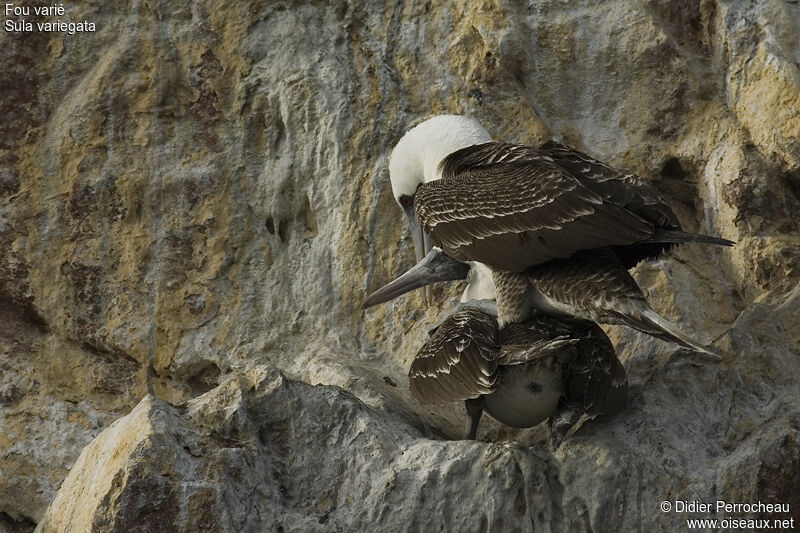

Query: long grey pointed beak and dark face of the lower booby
left=361, top=247, right=470, bottom=309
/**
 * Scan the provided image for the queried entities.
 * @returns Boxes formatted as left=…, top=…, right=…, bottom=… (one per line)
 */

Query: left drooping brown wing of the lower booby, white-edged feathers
left=408, top=309, right=499, bottom=405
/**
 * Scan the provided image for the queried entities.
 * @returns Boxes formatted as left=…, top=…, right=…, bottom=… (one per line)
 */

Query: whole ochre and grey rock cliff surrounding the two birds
left=0, top=0, right=800, bottom=531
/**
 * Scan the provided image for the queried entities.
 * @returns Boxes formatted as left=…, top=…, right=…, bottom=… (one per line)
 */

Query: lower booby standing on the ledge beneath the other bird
left=366, top=261, right=628, bottom=442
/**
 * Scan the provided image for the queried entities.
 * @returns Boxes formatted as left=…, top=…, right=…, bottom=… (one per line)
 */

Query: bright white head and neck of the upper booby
left=389, top=115, right=492, bottom=202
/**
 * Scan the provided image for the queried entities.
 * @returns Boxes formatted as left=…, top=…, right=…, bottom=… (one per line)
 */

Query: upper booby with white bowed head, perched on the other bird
left=389, top=115, right=733, bottom=353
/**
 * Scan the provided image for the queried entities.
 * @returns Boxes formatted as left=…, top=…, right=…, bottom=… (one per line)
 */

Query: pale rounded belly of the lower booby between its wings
left=484, top=358, right=564, bottom=428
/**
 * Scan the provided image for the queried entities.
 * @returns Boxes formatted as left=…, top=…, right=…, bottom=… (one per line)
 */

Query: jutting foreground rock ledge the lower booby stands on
left=37, top=348, right=800, bottom=532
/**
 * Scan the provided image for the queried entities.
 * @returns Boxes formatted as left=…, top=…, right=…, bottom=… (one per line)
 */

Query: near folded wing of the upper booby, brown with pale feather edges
left=415, top=142, right=656, bottom=272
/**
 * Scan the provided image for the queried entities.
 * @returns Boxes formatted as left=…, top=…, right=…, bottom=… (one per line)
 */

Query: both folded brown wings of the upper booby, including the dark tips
left=414, top=141, right=729, bottom=272
